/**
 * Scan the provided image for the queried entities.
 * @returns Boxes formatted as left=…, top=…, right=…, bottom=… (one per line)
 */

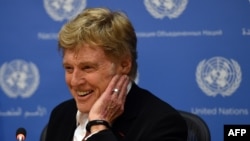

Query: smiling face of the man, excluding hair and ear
left=63, top=44, right=117, bottom=113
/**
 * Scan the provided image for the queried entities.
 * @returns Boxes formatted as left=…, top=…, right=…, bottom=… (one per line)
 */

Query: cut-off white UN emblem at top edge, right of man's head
left=144, top=0, right=188, bottom=19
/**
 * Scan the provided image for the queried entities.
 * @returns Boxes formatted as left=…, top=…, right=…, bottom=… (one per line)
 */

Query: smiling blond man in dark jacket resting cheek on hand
left=46, top=8, right=187, bottom=141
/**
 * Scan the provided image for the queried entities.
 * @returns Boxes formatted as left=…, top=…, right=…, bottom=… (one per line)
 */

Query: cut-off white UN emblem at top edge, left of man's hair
left=43, top=0, right=86, bottom=21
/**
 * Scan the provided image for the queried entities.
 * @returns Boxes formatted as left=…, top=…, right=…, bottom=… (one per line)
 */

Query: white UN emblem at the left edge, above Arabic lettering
left=0, top=60, right=40, bottom=98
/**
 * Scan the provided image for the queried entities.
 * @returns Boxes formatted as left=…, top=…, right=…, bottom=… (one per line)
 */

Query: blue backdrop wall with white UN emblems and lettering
left=0, top=0, right=250, bottom=141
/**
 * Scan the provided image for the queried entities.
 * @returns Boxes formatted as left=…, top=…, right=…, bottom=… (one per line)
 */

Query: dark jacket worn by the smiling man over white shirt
left=46, top=84, right=187, bottom=141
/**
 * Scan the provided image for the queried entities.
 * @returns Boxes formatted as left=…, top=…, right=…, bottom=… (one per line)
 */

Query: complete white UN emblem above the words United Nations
left=196, top=57, right=242, bottom=97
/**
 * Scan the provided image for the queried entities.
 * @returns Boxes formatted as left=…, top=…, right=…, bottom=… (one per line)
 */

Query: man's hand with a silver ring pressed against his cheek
left=89, top=75, right=129, bottom=124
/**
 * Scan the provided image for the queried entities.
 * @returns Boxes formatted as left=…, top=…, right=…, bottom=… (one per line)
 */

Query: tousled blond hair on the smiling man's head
left=58, top=8, right=137, bottom=80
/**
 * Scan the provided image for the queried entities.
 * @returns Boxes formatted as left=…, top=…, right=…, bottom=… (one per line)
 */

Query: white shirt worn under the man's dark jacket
left=73, top=82, right=132, bottom=141
